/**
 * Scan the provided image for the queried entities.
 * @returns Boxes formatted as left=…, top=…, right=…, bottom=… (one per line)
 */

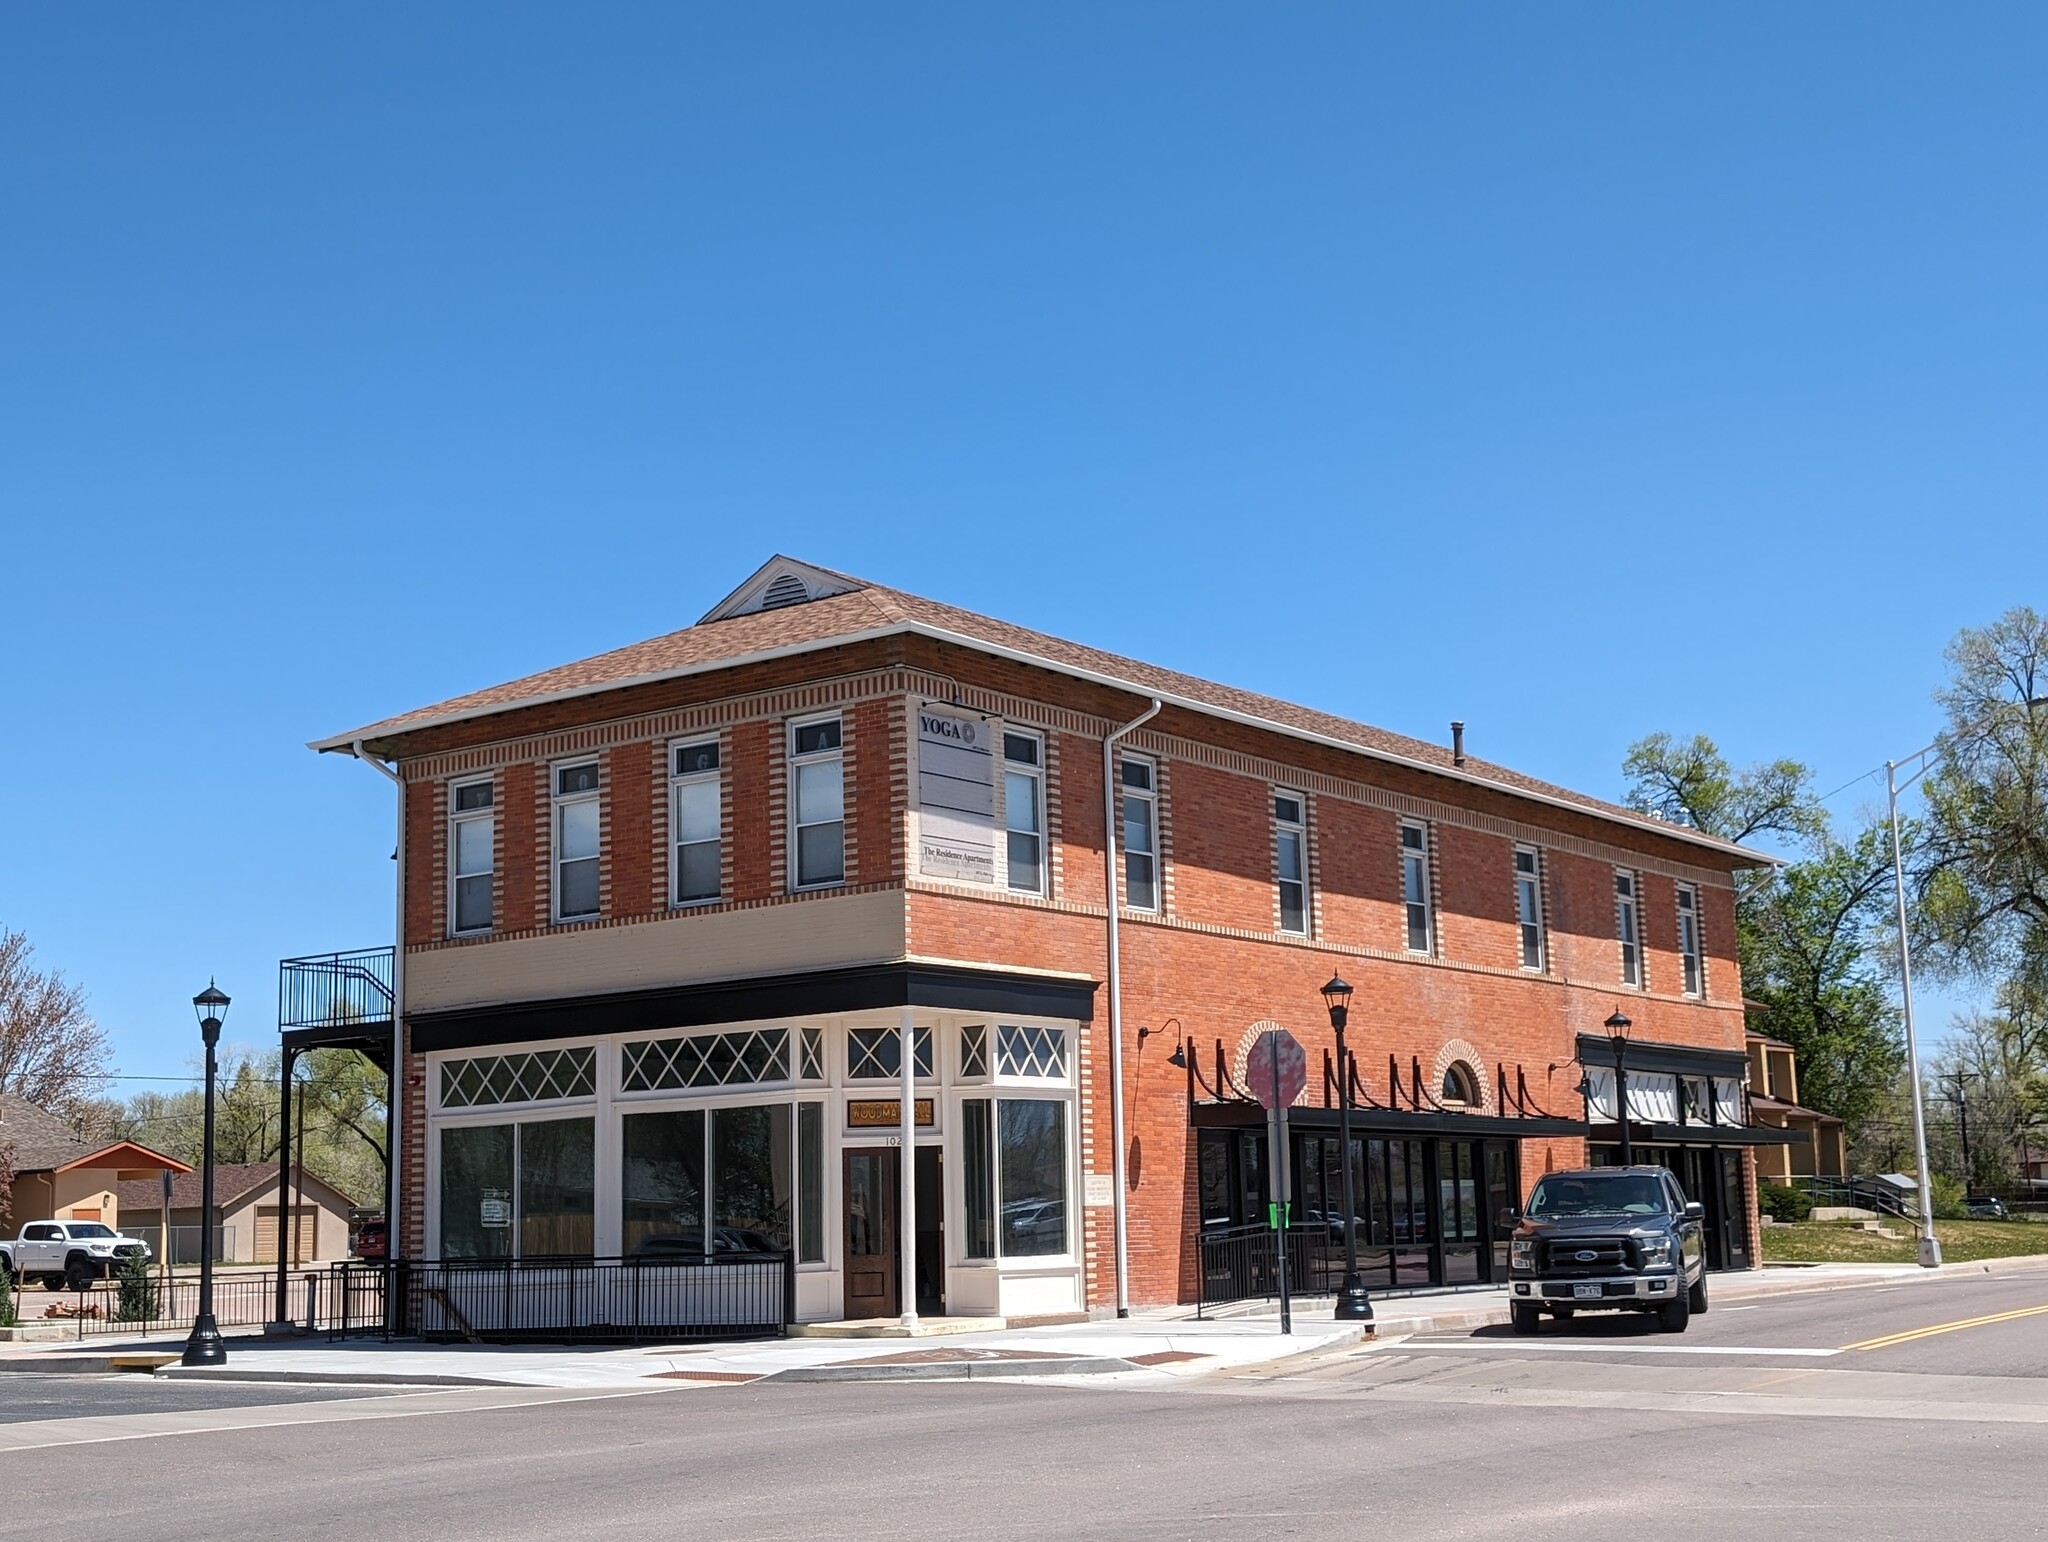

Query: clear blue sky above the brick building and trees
left=0, top=4, right=2048, bottom=1075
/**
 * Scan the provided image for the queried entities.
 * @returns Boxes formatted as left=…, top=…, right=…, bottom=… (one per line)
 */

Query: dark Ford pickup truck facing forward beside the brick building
left=1501, top=1167, right=1706, bottom=1333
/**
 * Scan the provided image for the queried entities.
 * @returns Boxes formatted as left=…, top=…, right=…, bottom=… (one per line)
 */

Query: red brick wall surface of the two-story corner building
left=356, top=581, right=1743, bottom=1307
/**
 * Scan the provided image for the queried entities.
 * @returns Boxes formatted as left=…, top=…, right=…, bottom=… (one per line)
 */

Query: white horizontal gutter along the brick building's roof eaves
left=307, top=620, right=1780, bottom=866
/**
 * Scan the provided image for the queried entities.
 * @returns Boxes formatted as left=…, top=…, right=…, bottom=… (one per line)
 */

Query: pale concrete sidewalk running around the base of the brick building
left=0, top=1257, right=2048, bottom=1388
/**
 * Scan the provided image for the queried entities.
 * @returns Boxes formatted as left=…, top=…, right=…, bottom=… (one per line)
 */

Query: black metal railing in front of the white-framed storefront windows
left=328, top=1253, right=797, bottom=1343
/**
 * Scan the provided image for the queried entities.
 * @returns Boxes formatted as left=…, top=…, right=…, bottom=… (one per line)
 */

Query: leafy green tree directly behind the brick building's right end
left=1622, top=733, right=1903, bottom=1126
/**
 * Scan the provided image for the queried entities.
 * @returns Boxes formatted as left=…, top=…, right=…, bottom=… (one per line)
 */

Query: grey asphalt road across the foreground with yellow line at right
left=0, top=1270, right=2048, bottom=1542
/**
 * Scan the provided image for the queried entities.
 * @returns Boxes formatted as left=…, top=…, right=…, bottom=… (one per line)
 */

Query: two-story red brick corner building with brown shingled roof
left=287, top=557, right=1774, bottom=1319
